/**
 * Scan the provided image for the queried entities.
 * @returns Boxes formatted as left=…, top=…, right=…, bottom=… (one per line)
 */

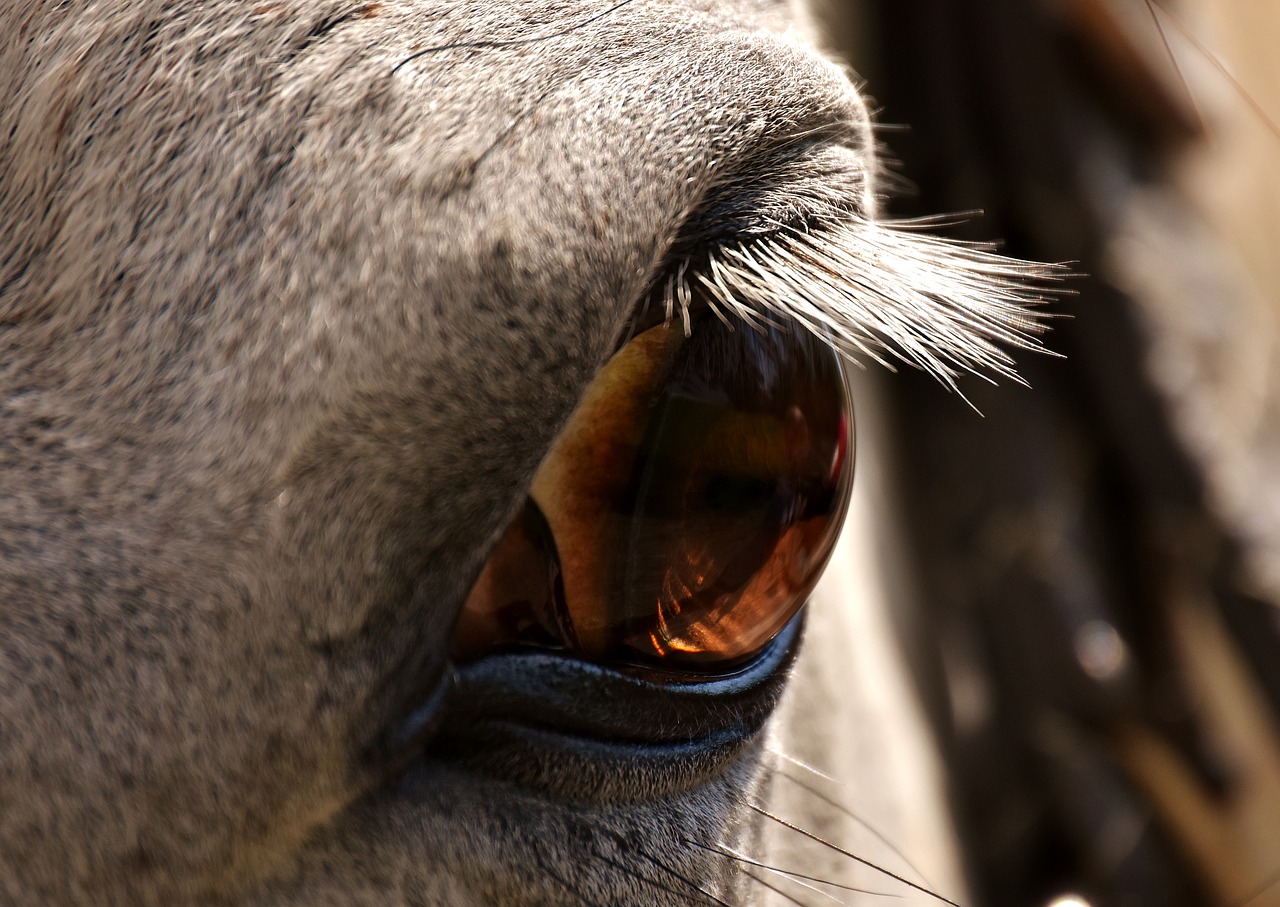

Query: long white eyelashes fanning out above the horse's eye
left=664, top=215, right=1070, bottom=390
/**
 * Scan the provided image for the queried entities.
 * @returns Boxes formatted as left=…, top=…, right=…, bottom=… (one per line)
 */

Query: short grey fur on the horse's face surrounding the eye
left=0, top=0, right=1039, bottom=907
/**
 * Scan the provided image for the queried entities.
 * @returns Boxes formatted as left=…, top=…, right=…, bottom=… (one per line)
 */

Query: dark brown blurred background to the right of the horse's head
left=819, top=0, right=1280, bottom=907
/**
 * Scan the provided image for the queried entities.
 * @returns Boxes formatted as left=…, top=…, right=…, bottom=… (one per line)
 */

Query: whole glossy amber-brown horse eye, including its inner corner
left=453, top=310, right=854, bottom=673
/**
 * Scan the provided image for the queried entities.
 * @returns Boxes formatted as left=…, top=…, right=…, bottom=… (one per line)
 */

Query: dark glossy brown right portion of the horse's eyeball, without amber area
left=611, top=319, right=850, bottom=665
